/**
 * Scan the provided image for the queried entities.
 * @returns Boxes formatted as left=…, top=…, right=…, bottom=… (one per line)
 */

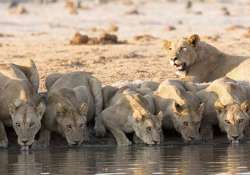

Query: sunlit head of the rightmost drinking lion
left=215, top=101, right=250, bottom=143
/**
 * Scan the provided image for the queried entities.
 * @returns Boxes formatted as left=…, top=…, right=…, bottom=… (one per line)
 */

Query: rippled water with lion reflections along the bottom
left=0, top=145, right=250, bottom=175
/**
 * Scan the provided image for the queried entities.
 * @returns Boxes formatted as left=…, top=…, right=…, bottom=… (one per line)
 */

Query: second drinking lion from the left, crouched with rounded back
left=36, top=72, right=103, bottom=147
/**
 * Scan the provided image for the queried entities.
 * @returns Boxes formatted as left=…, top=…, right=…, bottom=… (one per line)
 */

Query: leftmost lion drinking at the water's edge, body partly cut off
left=0, top=60, right=45, bottom=150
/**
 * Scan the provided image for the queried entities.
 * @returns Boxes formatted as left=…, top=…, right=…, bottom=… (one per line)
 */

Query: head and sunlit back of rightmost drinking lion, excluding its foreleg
left=207, top=77, right=249, bottom=143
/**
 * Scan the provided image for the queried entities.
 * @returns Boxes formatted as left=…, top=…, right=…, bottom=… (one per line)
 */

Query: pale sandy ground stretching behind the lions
left=0, top=0, right=250, bottom=89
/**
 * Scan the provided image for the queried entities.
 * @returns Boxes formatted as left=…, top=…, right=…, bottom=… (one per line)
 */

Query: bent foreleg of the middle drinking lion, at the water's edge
left=109, top=128, right=131, bottom=146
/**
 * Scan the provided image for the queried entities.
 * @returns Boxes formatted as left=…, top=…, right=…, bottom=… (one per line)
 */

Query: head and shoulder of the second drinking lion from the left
left=46, top=89, right=88, bottom=146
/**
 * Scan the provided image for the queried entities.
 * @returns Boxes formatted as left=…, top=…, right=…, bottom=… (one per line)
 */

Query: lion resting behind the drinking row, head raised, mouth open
left=164, top=34, right=250, bottom=82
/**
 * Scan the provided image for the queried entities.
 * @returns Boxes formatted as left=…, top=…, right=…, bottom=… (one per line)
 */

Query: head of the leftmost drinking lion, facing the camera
left=9, top=100, right=45, bottom=149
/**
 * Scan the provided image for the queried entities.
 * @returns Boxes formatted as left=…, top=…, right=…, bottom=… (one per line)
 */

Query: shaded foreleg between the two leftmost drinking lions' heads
left=32, top=129, right=50, bottom=148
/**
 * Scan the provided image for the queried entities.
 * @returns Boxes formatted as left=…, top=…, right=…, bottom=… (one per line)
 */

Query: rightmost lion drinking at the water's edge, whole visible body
left=197, top=77, right=250, bottom=143
